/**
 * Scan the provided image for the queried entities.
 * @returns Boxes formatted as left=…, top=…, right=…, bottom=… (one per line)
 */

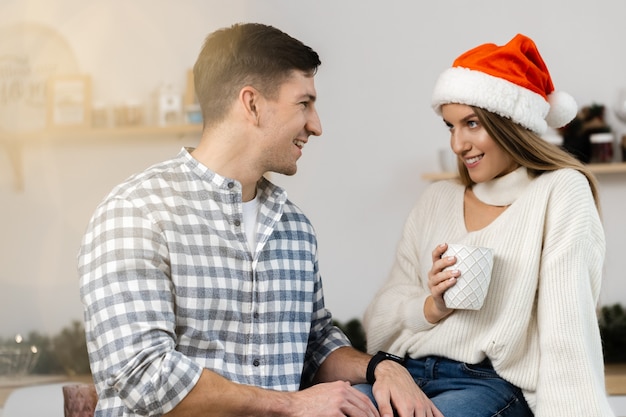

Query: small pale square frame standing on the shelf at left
left=47, top=75, right=91, bottom=128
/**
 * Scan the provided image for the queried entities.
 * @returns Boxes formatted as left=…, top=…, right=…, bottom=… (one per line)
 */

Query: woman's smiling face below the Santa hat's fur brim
left=441, top=104, right=519, bottom=183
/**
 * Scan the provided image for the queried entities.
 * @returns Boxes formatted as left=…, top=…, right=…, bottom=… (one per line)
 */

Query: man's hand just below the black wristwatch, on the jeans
left=372, top=361, right=443, bottom=417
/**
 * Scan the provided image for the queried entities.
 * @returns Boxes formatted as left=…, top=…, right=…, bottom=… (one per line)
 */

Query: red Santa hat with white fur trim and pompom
left=432, top=34, right=578, bottom=134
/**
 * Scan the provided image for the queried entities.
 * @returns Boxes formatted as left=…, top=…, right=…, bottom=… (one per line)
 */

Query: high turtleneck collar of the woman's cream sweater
left=472, top=166, right=532, bottom=206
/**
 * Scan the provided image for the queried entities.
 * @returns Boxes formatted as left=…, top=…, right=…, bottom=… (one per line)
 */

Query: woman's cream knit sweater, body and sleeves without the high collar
left=364, top=169, right=613, bottom=417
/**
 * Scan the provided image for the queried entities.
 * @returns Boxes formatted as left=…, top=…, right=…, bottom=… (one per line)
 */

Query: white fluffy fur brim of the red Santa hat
left=431, top=67, right=548, bottom=135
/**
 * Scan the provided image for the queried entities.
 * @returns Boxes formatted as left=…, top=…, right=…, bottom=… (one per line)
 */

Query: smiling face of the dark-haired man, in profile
left=260, top=71, right=322, bottom=175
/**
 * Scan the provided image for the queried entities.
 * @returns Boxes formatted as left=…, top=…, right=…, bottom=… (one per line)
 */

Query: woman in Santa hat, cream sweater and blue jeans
left=364, top=35, right=613, bottom=417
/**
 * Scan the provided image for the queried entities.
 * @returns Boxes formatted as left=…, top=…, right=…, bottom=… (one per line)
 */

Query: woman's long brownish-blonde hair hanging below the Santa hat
left=458, top=106, right=600, bottom=211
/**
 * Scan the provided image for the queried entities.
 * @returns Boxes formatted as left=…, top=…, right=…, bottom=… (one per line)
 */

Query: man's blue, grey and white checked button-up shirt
left=78, top=149, right=349, bottom=416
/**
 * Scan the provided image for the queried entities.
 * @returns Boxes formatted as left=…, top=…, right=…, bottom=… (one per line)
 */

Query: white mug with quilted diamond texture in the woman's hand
left=443, top=243, right=493, bottom=310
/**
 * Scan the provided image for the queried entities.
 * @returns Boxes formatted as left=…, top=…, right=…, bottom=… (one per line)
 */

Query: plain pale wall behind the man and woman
left=0, top=0, right=626, bottom=336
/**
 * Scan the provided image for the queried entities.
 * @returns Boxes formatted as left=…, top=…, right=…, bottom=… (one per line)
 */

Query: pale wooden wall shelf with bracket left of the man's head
left=0, top=124, right=202, bottom=191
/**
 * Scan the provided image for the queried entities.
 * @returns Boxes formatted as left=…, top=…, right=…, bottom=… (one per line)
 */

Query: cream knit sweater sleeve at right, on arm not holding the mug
left=536, top=170, right=613, bottom=417
